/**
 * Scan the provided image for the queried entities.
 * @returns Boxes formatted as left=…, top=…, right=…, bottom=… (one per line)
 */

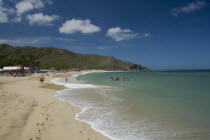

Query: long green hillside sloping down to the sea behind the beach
left=0, top=44, right=147, bottom=70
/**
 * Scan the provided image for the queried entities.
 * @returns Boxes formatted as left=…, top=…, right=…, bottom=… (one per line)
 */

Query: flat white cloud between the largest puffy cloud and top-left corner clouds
left=27, top=13, right=59, bottom=25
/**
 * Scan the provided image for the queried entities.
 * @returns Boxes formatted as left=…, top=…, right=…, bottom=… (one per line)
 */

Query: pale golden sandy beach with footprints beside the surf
left=0, top=72, right=109, bottom=140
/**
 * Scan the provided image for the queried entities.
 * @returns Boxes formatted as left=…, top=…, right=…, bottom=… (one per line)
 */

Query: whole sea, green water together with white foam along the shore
left=52, top=70, right=210, bottom=140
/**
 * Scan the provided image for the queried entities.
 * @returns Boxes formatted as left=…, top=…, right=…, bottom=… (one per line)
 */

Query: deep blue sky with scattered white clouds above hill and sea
left=0, top=0, right=210, bottom=69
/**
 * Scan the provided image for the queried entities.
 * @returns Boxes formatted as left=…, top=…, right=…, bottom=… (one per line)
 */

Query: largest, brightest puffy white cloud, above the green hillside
left=59, top=19, right=101, bottom=34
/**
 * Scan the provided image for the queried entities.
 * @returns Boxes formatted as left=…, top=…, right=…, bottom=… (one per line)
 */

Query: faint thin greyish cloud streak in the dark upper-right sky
left=171, top=1, right=206, bottom=16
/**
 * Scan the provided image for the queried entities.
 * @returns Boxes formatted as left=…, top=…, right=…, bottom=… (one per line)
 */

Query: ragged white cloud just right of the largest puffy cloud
left=106, top=27, right=138, bottom=41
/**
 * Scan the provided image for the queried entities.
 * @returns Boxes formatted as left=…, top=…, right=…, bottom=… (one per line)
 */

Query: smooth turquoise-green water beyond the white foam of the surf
left=81, top=71, right=210, bottom=139
